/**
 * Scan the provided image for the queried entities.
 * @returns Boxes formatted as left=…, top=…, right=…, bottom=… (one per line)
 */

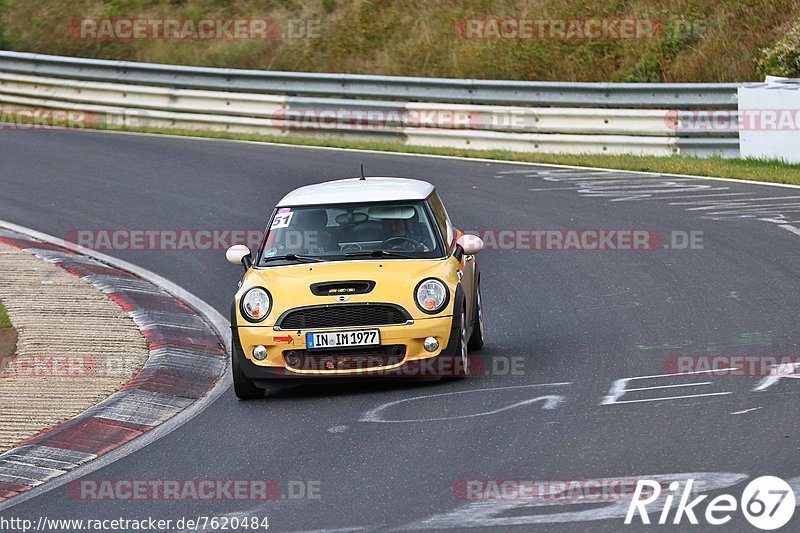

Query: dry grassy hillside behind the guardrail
left=0, top=0, right=800, bottom=82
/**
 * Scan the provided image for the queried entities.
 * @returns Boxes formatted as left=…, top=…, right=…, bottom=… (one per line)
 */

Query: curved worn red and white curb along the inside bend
left=0, top=225, right=228, bottom=502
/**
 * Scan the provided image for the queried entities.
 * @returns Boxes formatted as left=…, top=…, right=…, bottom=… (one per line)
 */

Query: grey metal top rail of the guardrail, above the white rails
left=0, top=51, right=741, bottom=109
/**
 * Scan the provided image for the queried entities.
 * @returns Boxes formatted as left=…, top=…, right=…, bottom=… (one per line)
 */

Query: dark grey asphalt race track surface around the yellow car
left=0, top=130, right=800, bottom=532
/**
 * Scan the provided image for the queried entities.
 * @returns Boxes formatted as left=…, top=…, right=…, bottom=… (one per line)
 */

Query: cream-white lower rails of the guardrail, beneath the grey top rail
left=0, top=58, right=739, bottom=157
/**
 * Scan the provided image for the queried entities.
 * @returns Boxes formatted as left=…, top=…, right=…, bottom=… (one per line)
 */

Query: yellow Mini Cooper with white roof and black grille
left=226, top=177, right=483, bottom=399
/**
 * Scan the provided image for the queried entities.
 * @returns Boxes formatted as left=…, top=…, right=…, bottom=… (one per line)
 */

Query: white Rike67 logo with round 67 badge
left=625, top=476, right=795, bottom=530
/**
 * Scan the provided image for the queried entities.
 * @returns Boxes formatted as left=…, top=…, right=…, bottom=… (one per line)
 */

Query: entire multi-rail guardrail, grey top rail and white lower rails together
left=0, top=51, right=741, bottom=156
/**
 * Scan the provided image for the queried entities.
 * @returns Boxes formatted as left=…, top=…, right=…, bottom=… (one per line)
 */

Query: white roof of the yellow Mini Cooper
left=277, top=177, right=433, bottom=207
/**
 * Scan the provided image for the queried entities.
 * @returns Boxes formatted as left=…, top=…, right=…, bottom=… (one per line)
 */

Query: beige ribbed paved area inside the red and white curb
left=0, top=243, right=149, bottom=452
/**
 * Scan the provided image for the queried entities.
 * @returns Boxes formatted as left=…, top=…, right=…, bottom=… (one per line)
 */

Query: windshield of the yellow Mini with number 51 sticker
left=259, top=201, right=443, bottom=266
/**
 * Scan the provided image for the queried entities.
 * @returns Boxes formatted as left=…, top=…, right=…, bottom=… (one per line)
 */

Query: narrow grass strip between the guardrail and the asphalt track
left=100, top=123, right=800, bottom=185
